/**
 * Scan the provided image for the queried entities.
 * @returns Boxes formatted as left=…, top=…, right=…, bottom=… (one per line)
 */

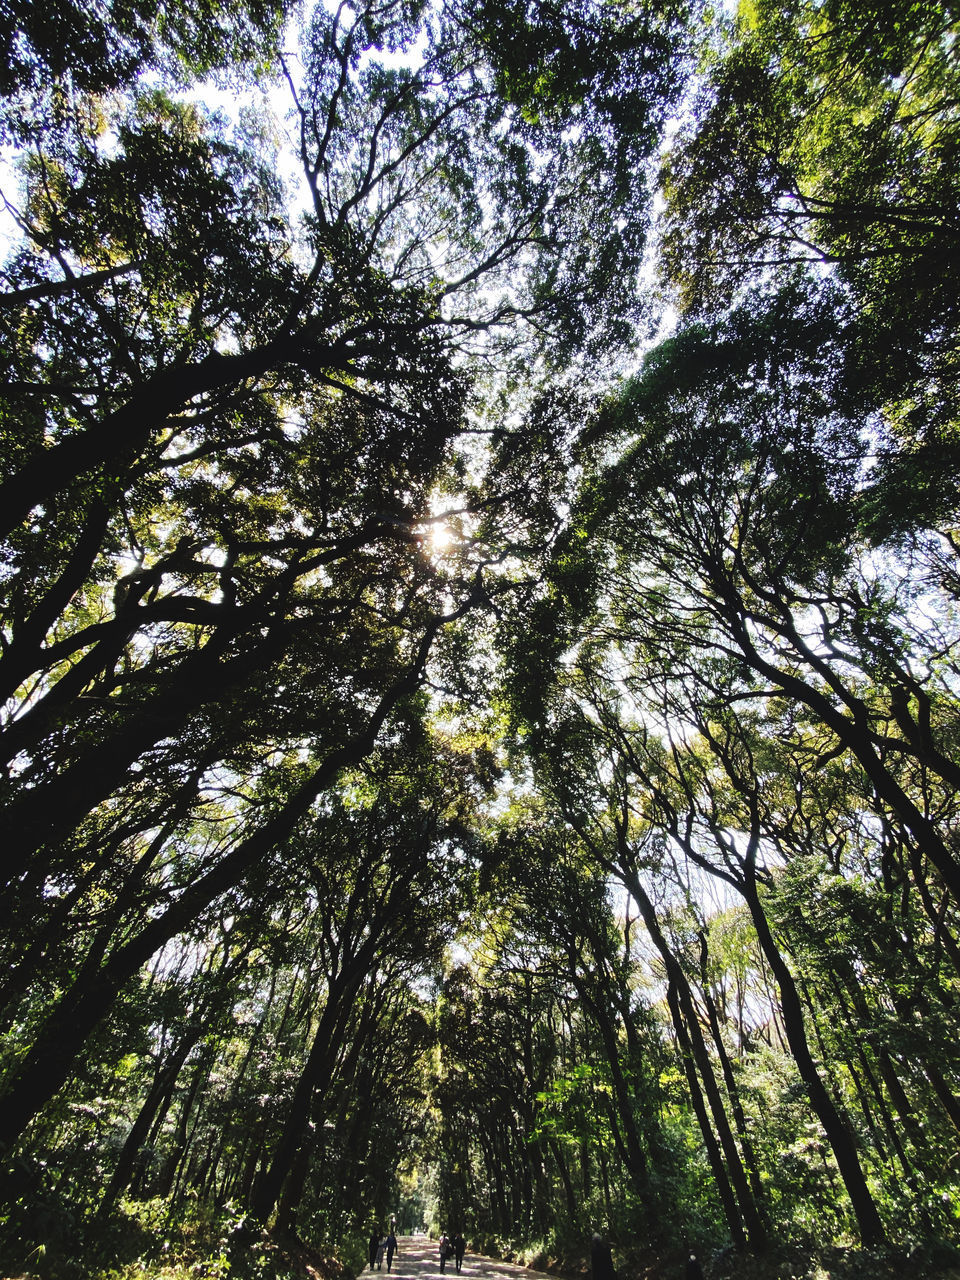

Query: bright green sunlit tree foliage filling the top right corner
left=662, top=0, right=960, bottom=532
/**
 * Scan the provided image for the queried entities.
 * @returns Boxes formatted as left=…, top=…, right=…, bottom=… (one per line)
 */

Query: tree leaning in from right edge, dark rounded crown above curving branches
left=568, top=292, right=960, bottom=900
